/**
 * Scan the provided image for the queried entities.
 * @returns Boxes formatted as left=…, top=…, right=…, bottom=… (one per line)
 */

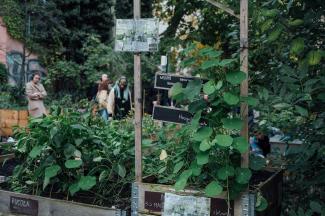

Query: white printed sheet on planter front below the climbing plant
left=163, top=193, right=211, bottom=216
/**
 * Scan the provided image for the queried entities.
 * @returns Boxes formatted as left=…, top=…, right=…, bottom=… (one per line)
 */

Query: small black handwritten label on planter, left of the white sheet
left=144, top=191, right=165, bottom=212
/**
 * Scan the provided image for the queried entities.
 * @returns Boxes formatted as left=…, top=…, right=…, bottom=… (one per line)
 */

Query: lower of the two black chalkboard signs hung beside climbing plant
left=152, top=105, right=193, bottom=124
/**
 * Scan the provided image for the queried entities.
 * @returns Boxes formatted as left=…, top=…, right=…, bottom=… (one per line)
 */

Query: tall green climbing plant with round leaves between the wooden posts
left=166, top=44, right=265, bottom=204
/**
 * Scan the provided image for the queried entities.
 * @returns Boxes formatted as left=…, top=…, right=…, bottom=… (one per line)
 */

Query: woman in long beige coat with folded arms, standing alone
left=26, top=72, right=47, bottom=118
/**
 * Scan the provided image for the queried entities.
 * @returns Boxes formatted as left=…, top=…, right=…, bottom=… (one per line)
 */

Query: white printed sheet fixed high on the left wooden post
left=115, top=19, right=159, bottom=52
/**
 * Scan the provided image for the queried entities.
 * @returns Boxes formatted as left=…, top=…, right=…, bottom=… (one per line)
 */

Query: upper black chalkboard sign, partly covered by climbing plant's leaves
left=155, top=73, right=208, bottom=90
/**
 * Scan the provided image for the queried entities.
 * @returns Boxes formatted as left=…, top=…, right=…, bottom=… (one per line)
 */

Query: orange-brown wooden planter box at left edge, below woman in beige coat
left=0, top=109, right=28, bottom=137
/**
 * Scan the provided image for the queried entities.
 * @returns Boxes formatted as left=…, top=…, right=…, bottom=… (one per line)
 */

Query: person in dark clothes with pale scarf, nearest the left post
left=107, top=76, right=132, bottom=119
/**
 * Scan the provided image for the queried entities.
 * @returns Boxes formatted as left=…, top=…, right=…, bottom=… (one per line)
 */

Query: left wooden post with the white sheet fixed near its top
left=133, top=0, right=142, bottom=183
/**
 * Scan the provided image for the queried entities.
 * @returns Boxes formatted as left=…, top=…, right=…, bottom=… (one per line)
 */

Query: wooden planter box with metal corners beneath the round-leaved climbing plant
left=131, top=171, right=283, bottom=216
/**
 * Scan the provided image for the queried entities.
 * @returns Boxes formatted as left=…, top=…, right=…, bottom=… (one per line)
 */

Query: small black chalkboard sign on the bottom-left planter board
left=10, top=196, right=38, bottom=216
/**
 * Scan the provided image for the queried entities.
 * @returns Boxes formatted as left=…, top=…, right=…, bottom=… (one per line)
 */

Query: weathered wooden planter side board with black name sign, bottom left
left=0, top=190, right=126, bottom=216
